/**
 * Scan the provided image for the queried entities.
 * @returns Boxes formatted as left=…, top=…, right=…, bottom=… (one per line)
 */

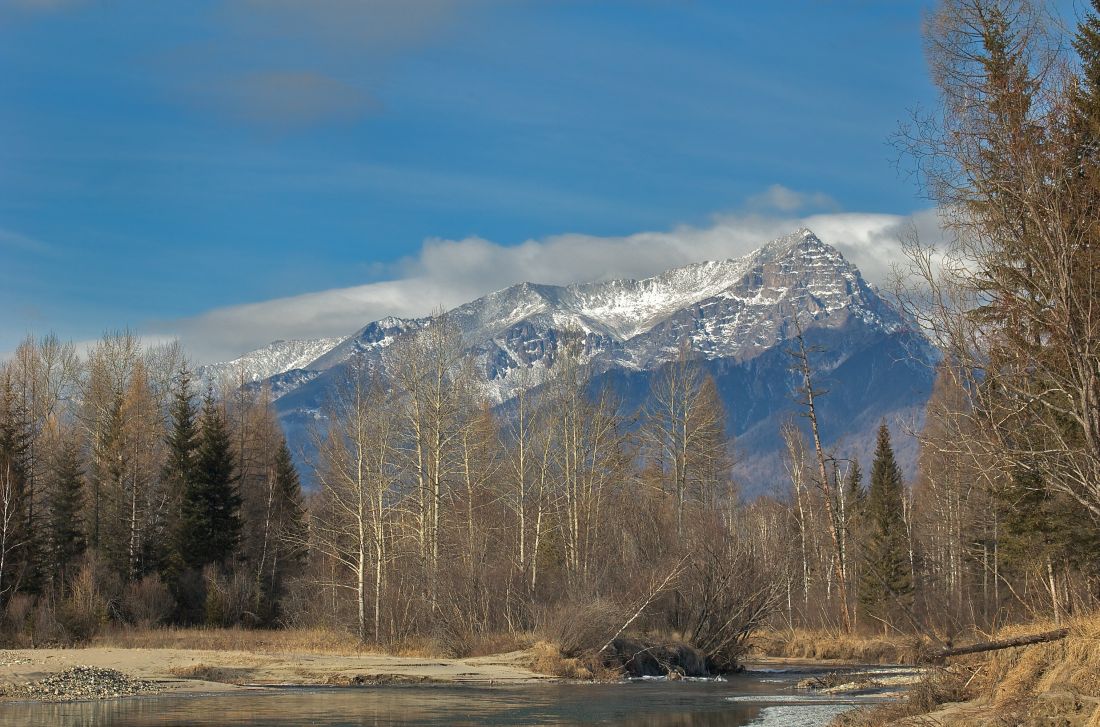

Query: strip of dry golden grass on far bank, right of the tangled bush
left=749, top=629, right=927, bottom=664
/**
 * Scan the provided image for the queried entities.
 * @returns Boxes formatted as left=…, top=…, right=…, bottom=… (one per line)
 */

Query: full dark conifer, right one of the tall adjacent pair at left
left=176, top=392, right=241, bottom=569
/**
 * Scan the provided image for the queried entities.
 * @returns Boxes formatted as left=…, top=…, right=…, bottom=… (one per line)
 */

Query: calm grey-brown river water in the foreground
left=0, top=669, right=893, bottom=727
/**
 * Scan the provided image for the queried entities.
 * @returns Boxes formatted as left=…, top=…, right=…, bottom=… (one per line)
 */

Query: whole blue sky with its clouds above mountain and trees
left=0, top=0, right=1012, bottom=360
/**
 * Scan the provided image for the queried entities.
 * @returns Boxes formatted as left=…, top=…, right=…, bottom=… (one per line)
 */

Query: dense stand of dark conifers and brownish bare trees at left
left=0, top=333, right=306, bottom=640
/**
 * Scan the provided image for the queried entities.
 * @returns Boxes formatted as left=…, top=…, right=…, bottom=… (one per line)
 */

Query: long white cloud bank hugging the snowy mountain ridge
left=157, top=205, right=938, bottom=362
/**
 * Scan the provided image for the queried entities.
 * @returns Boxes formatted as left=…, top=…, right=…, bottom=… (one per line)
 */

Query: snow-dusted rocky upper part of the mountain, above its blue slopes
left=210, top=228, right=904, bottom=401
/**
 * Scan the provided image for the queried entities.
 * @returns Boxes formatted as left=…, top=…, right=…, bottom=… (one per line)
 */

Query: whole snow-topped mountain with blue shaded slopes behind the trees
left=212, top=229, right=936, bottom=495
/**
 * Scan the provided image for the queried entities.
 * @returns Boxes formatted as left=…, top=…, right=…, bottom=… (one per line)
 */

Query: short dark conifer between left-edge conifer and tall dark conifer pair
left=47, top=437, right=86, bottom=588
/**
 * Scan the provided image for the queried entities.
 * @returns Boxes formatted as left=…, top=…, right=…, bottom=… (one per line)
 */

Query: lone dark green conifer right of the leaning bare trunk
left=859, top=421, right=913, bottom=630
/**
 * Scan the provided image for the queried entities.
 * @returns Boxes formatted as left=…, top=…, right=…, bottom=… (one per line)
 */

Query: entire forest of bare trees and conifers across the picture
left=0, top=0, right=1100, bottom=670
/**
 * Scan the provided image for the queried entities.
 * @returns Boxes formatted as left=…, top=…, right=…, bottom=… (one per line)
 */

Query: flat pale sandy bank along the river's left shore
left=0, top=648, right=551, bottom=693
